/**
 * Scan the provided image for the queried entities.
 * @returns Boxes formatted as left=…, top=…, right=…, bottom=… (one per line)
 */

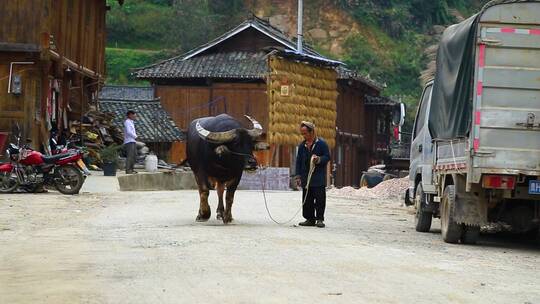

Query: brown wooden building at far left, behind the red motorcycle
left=0, top=0, right=118, bottom=150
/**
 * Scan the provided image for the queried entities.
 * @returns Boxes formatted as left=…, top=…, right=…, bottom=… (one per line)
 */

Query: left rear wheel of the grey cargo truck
left=441, top=185, right=463, bottom=244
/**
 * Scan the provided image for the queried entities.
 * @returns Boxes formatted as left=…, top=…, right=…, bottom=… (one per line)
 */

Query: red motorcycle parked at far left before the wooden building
left=0, top=138, right=88, bottom=195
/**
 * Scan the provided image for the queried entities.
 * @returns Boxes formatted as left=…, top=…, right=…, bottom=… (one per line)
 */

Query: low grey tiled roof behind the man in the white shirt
left=99, top=86, right=185, bottom=143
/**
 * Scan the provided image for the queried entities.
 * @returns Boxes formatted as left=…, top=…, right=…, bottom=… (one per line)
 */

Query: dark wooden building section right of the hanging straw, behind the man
left=333, top=68, right=397, bottom=187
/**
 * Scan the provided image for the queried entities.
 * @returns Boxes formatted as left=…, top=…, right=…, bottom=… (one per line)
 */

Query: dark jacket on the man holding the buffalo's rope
left=296, top=138, right=330, bottom=188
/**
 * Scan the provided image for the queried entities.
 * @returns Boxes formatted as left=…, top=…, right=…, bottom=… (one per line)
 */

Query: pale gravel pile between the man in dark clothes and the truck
left=328, top=176, right=409, bottom=199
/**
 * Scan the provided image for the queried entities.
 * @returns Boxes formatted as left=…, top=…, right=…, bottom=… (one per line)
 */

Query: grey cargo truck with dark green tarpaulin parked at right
left=406, top=1, right=540, bottom=243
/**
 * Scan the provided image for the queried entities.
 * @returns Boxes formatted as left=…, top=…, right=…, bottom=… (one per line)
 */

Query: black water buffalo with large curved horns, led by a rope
left=187, top=114, right=264, bottom=224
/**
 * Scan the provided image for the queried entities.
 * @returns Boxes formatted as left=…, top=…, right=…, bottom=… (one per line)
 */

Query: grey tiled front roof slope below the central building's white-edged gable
left=135, top=52, right=268, bottom=79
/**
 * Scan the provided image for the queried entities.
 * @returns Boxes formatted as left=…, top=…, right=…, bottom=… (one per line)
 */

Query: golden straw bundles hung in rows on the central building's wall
left=268, top=56, right=338, bottom=148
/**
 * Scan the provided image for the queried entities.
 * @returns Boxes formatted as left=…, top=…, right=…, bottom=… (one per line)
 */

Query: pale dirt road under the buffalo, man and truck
left=0, top=177, right=540, bottom=303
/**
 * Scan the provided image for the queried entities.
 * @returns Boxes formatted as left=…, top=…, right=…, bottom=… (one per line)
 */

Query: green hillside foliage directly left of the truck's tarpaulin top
left=340, top=0, right=487, bottom=129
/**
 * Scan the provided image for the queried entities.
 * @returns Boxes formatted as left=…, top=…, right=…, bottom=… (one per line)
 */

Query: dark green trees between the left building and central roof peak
left=107, top=0, right=247, bottom=51
